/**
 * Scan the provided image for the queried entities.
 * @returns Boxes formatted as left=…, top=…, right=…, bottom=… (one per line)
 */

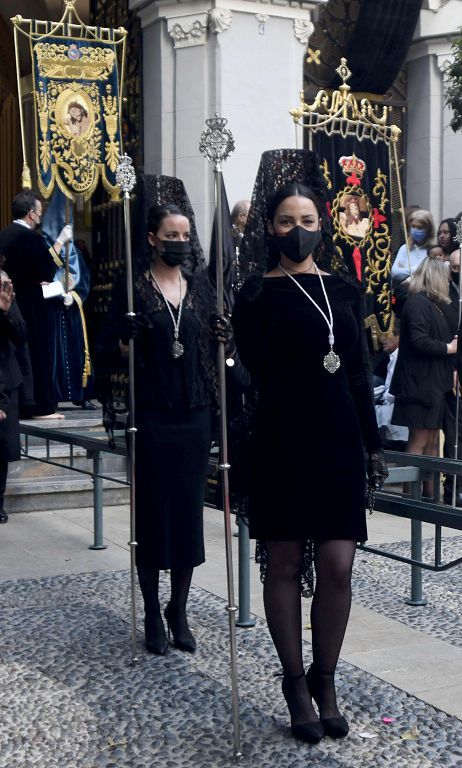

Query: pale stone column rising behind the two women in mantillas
left=131, top=0, right=324, bottom=249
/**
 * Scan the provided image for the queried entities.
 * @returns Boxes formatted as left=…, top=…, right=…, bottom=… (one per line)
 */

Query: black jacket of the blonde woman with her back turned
left=390, top=293, right=453, bottom=407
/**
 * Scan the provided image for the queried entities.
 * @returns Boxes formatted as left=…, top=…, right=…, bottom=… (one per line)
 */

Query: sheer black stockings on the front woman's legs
left=263, top=540, right=356, bottom=721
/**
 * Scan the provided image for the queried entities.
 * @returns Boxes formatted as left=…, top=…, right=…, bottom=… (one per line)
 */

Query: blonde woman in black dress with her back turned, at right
left=390, top=258, right=457, bottom=488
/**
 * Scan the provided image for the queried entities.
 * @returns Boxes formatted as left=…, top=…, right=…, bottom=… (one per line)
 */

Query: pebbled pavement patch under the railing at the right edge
left=353, top=536, right=462, bottom=648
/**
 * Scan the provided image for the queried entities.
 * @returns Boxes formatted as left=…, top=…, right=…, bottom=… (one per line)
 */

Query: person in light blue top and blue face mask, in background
left=391, top=209, right=435, bottom=285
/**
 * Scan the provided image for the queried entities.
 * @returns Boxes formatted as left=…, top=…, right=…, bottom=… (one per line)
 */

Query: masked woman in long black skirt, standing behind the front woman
left=117, top=205, right=212, bottom=655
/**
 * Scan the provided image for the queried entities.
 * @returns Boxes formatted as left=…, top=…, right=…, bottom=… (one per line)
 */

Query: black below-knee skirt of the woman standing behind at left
left=135, top=406, right=211, bottom=570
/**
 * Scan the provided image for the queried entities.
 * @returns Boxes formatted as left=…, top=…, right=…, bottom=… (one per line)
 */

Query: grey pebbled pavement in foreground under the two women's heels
left=0, top=559, right=462, bottom=768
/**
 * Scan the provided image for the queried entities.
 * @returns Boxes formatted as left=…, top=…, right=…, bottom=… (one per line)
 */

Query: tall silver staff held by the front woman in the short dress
left=199, top=114, right=242, bottom=761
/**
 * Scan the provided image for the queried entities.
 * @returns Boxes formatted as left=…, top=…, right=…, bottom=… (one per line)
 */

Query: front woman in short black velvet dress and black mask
left=233, top=182, right=386, bottom=743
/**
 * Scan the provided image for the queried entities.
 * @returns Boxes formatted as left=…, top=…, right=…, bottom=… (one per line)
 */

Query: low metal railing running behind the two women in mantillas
left=20, top=423, right=462, bottom=612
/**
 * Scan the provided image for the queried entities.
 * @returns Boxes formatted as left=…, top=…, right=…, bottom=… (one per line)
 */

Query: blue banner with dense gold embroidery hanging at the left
left=30, top=34, right=122, bottom=200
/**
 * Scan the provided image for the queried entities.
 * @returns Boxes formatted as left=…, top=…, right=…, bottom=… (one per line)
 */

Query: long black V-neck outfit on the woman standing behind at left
left=135, top=276, right=211, bottom=569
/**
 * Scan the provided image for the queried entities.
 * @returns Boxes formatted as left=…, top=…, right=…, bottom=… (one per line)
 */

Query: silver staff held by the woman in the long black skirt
left=116, top=155, right=138, bottom=663
